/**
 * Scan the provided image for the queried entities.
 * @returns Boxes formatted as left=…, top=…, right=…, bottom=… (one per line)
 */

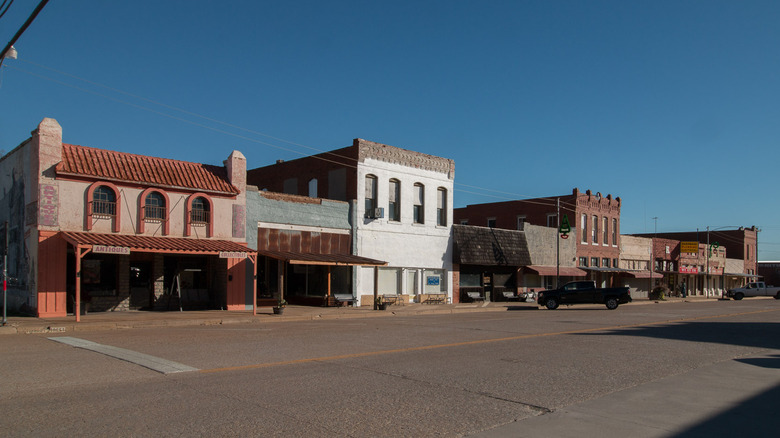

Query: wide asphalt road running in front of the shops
left=0, top=299, right=780, bottom=437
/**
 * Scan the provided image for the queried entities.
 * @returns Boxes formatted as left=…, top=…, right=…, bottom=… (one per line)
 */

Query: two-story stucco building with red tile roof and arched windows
left=0, top=119, right=254, bottom=319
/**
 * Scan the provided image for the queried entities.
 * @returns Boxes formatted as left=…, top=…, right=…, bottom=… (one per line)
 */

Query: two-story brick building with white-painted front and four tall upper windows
left=247, top=139, right=455, bottom=305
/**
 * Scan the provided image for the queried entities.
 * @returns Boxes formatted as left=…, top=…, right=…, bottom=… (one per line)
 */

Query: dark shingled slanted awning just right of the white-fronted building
left=452, top=225, right=531, bottom=266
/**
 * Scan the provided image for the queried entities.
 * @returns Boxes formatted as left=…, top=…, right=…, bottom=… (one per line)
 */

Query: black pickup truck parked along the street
left=536, top=281, right=631, bottom=310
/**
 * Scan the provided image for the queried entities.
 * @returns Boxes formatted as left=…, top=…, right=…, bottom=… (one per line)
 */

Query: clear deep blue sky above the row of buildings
left=0, top=0, right=780, bottom=260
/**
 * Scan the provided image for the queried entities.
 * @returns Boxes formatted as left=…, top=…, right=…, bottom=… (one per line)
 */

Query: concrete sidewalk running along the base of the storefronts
left=0, top=298, right=717, bottom=335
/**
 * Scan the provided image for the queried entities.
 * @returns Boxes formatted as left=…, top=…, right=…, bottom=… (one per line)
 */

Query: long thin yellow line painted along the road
left=199, top=309, right=780, bottom=373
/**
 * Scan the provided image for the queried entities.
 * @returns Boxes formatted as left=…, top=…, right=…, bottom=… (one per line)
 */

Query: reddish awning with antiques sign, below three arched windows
left=61, top=231, right=255, bottom=258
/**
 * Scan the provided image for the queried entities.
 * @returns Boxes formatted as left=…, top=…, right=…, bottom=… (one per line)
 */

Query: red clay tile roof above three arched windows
left=57, top=143, right=239, bottom=194
